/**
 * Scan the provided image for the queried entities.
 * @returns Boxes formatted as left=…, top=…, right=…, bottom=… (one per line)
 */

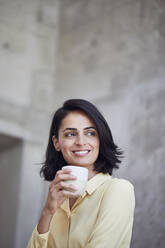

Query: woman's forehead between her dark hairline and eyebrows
left=60, top=110, right=95, bottom=129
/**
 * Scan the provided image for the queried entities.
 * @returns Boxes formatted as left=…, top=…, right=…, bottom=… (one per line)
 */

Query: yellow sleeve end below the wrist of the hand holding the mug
left=27, top=226, right=49, bottom=248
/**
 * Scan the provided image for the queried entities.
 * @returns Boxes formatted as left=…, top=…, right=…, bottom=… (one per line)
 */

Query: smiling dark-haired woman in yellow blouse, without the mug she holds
left=27, top=99, right=135, bottom=248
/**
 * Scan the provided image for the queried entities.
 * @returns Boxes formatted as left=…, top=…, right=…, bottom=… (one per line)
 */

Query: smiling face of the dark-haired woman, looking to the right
left=53, top=111, right=99, bottom=169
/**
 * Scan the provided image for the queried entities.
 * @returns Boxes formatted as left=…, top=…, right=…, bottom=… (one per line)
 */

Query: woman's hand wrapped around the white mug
left=44, top=169, right=76, bottom=215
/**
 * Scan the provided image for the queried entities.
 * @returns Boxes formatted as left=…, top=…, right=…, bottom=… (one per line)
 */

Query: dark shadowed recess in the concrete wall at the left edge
left=0, top=134, right=22, bottom=248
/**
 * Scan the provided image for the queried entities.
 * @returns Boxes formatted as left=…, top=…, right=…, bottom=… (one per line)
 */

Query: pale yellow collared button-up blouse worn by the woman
left=27, top=173, right=135, bottom=248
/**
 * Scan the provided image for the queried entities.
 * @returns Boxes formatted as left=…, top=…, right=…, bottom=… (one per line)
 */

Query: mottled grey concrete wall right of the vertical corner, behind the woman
left=57, top=0, right=165, bottom=248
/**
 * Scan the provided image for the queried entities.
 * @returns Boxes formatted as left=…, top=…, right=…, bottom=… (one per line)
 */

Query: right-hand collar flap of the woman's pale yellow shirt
left=86, top=173, right=111, bottom=195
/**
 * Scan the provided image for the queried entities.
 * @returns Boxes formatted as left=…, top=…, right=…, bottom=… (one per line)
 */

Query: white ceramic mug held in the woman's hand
left=62, top=165, right=88, bottom=196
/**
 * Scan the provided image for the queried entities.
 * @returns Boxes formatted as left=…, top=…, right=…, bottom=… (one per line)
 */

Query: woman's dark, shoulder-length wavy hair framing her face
left=40, top=99, right=123, bottom=181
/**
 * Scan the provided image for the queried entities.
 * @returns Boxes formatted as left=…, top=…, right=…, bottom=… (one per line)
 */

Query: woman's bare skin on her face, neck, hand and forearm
left=37, top=111, right=99, bottom=233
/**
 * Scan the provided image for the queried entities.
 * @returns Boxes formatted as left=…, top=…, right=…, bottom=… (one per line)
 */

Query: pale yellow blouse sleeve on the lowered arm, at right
left=85, top=179, right=135, bottom=248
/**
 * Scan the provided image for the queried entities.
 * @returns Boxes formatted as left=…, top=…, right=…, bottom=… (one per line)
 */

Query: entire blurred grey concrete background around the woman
left=0, top=0, right=165, bottom=248
